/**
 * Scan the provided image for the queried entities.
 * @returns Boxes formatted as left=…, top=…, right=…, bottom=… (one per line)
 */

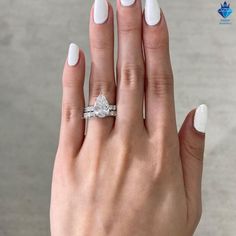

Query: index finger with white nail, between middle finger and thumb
left=143, top=0, right=177, bottom=134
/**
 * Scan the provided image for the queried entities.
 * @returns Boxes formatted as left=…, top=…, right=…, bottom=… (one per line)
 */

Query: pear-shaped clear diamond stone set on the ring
left=94, top=94, right=109, bottom=118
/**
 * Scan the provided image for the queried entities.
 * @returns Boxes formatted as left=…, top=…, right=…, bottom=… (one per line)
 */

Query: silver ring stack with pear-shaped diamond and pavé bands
left=83, top=94, right=117, bottom=119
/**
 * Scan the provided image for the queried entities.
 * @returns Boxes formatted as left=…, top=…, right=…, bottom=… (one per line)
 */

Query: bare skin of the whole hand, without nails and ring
left=50, top=0, right=205, bottom=236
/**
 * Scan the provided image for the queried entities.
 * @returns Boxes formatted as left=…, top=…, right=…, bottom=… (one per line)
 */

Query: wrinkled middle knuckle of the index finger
left=147, top=73, right=174, bottom=96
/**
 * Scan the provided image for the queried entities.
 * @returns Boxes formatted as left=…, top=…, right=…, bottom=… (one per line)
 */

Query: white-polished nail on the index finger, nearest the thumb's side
left=145, top=0, right=161, bottom=26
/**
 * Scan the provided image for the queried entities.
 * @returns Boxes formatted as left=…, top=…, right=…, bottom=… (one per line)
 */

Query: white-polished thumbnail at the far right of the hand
left=194, top=104, right=208, bottom=133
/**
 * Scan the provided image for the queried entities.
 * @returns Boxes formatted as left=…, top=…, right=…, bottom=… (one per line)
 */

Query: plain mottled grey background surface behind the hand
left=0, top=0, right=236, bottom=236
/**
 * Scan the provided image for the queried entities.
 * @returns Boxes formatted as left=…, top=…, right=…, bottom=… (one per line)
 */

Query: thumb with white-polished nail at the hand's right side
left=179, top=105, right=207, bottom=223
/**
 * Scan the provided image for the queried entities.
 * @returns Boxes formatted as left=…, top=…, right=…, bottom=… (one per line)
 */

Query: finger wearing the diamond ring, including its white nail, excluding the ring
left=87, top=0, right=116, bottom=135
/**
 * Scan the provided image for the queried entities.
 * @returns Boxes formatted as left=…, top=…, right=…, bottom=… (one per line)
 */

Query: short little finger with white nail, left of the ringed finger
left=59, top=44, right=85, bottom=157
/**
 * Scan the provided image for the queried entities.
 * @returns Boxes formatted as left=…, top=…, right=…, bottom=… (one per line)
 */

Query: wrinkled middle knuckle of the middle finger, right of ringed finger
left=120, top=64, right=144, bottom=89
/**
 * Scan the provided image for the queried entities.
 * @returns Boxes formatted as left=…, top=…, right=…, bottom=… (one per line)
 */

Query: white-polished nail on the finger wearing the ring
left=94, top=0, right=108, bottom=24
